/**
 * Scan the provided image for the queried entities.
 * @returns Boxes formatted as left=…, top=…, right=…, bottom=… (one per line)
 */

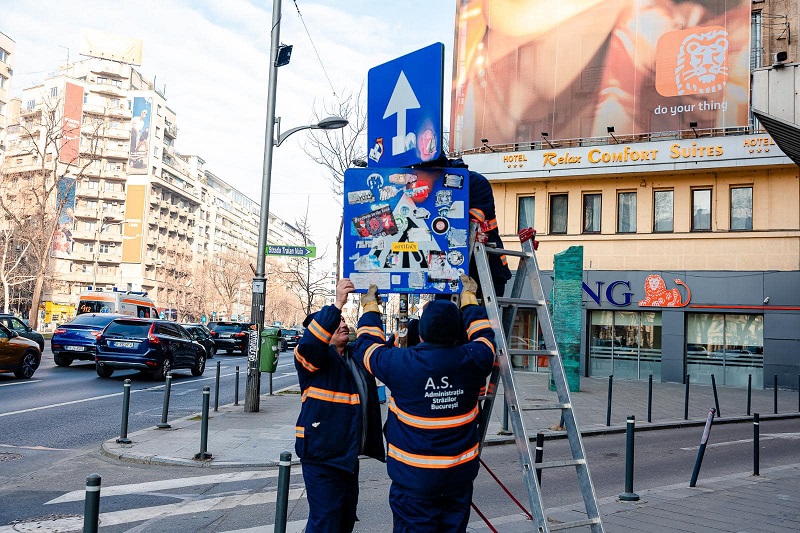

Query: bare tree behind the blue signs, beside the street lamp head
left=303, top=85, right=367, bottom=281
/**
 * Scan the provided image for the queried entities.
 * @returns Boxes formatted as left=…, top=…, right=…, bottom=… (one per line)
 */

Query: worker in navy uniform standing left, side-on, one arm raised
left=294, top=279, right=386, bottom=533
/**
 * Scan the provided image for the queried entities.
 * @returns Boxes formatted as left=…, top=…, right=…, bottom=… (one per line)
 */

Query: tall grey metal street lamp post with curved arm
left=244, top=0, right=347, bottom=413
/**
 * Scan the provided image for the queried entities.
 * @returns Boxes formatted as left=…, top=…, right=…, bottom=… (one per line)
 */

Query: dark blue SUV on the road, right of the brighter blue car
left=95, top=318, right=206, bottom=381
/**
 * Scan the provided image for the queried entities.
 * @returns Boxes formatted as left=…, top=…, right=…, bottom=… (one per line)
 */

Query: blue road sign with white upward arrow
left=367, top=43, right=444, bottom=168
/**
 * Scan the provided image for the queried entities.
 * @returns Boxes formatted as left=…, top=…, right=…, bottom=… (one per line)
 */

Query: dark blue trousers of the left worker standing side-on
left=303, top=462, right=358, bottom=533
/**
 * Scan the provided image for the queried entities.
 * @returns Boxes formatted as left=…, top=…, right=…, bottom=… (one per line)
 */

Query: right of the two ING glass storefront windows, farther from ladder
left=686, top=313, right=764, bottom=387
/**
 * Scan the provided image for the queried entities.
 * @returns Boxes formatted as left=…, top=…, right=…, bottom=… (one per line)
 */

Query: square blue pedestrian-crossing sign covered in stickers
left=344, top=168, right=469, bottom=294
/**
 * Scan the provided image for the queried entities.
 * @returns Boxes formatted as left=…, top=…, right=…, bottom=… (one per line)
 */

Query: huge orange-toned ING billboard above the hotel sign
left=450, top=0, right=750, bottom=152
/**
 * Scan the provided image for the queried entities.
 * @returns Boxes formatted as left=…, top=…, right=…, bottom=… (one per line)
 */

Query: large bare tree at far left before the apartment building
left=0, top=97, right=106, bottom=328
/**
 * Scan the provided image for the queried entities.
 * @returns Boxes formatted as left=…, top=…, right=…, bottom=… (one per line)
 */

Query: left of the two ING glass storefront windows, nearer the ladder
left=589, top=311, right=661, bottom=381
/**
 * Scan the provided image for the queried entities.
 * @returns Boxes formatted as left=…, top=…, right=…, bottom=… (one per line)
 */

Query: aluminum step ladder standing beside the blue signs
left=471, top=229, right=605, bottom=533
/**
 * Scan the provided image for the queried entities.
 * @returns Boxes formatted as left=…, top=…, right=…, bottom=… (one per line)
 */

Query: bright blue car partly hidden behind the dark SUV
left=50, top=313, right=125, bottom=366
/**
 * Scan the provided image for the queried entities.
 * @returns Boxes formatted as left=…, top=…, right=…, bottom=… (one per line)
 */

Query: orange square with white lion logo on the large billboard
left=656, top=26, right=729, bottom=96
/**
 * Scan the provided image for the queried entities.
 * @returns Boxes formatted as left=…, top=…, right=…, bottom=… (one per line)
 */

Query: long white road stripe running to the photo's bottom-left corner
left=0, top=488, right=305, bottom=533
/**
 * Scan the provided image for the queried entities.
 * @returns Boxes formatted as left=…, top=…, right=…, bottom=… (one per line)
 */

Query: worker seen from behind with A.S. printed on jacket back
left=356, top=276, right=495, bottom=533
